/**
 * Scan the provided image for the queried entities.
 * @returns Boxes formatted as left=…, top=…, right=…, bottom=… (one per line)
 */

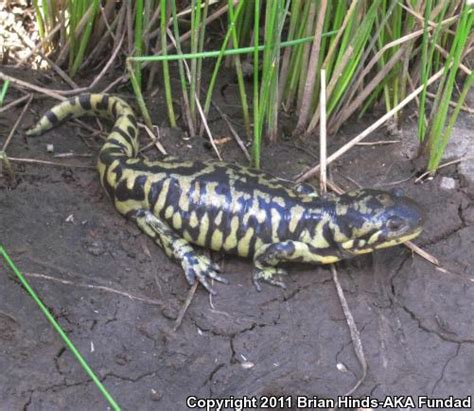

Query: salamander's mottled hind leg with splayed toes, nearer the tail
left=134, top=210, right=228, bottom=294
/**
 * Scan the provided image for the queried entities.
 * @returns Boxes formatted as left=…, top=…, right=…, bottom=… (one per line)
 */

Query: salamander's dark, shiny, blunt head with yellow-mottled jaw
left=334, top=189, right=424, bottom=255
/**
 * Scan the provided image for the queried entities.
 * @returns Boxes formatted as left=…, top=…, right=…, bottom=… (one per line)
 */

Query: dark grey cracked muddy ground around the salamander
left=0, top=68, right=474, bottom=411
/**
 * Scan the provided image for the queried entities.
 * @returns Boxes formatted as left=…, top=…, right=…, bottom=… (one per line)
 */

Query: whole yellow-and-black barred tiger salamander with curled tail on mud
left=27, top=94, right=423, bottom=292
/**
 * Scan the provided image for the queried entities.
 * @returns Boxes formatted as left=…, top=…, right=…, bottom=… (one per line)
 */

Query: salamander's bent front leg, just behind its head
left=253, top=240, right=340, bottom=291
